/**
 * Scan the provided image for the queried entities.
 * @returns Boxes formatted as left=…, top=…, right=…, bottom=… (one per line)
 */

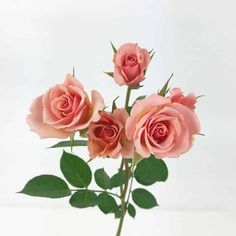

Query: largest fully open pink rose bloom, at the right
left=126, top=94, right=200, bottom=158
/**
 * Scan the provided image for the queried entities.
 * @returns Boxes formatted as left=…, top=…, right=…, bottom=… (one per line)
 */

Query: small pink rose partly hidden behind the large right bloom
left=170, top=88, right=197, bottom=110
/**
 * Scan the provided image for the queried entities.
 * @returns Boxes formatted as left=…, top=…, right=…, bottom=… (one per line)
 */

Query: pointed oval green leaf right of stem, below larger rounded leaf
left=132, top=188, right=158, bottom=209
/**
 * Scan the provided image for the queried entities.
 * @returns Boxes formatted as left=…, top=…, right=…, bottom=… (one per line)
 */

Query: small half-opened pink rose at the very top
left=113, top=43, right=150, bottom=85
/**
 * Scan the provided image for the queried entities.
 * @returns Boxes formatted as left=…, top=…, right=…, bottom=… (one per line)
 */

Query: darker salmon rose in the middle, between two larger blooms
left=88, top=109, right=134, bottom=158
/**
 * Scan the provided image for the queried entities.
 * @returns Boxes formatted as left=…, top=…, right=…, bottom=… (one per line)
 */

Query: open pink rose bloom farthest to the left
left=27, top=74, right=104, bottom=138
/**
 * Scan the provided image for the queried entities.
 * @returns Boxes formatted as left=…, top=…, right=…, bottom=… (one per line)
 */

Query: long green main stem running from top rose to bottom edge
left=116, top=87, right=131, bottom=236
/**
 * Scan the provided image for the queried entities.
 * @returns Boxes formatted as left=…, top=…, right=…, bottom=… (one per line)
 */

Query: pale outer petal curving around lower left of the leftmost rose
left=26, top=96, right=70, bottom=139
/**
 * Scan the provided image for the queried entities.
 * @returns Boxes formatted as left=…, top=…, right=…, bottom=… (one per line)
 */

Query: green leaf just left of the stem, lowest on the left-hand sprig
left=98, top=193, right=119, bottom=214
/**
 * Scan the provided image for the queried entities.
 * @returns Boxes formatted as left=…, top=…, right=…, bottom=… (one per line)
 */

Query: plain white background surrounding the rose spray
left=0, top=0, right=236, bottom=236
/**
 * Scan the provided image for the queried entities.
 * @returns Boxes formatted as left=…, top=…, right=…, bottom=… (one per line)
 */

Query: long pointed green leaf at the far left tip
left=19, top=175, right=71, bottom=198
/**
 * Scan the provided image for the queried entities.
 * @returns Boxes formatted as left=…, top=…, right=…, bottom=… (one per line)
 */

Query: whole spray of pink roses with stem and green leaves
left=20, top=43, right=200, bottom=236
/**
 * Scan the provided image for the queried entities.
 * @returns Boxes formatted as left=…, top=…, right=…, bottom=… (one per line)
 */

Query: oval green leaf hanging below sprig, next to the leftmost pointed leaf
left=70, top=190, right=98, bottom=208
